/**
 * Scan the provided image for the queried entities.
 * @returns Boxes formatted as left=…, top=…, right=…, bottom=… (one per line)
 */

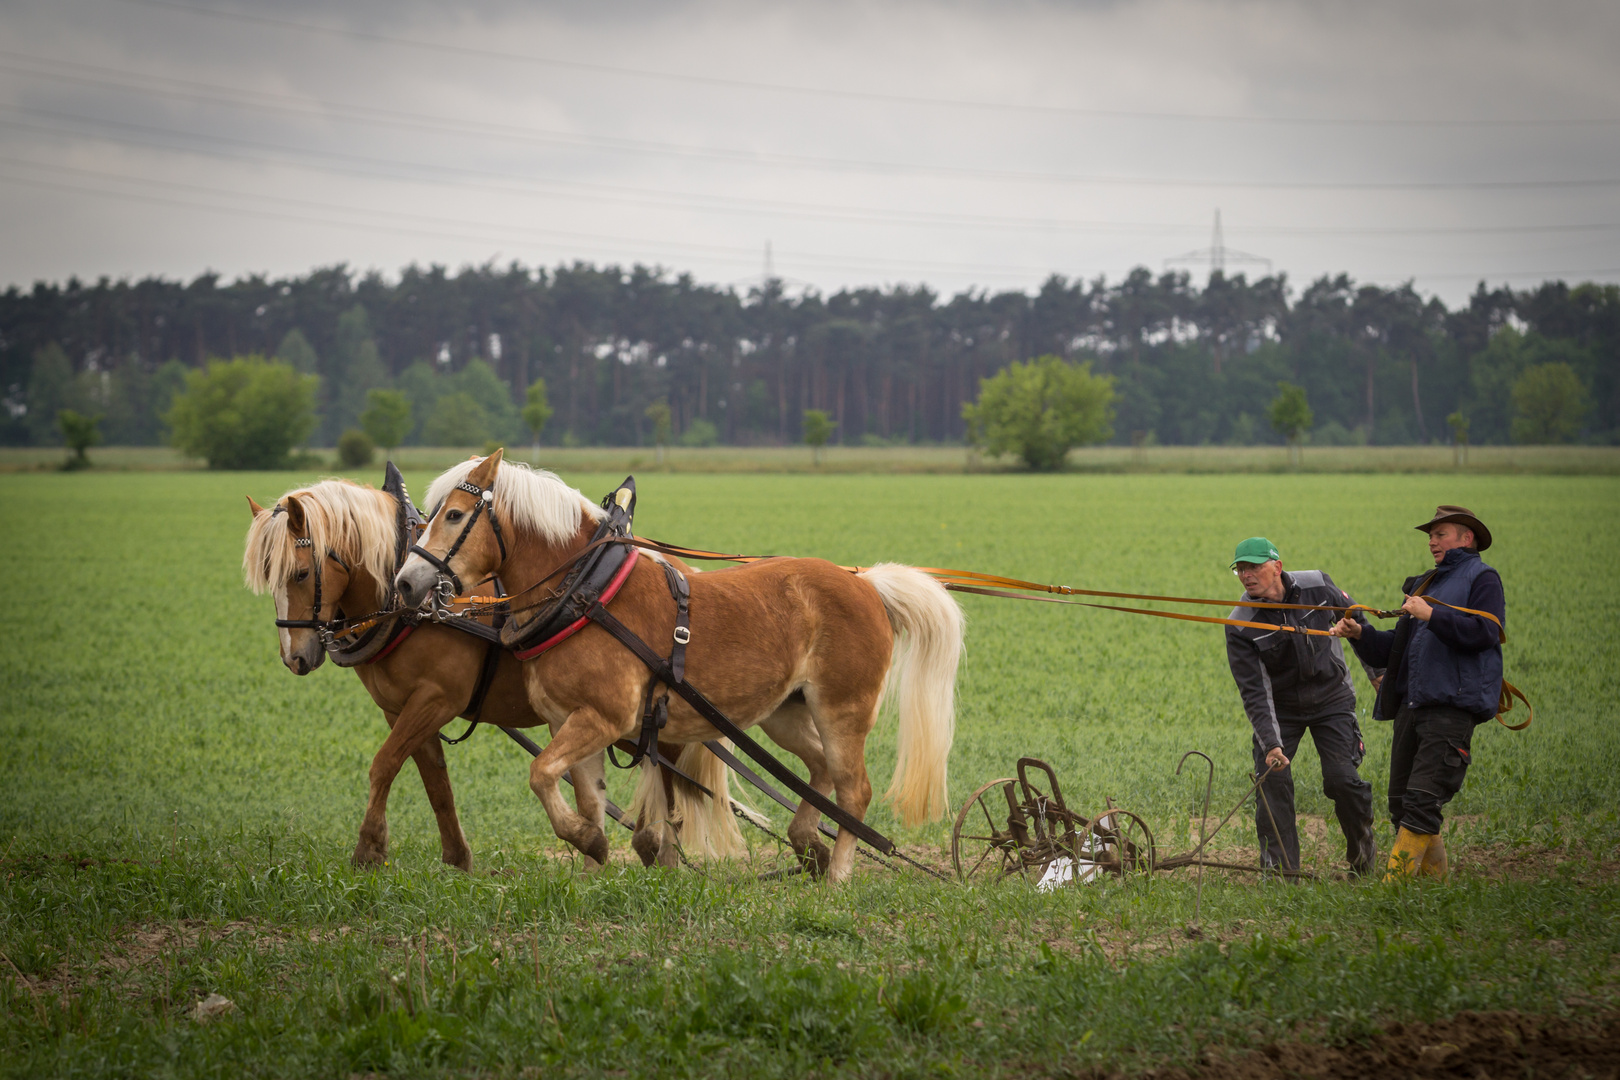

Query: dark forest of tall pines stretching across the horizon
left=0, top=264, right=1620, bottom=447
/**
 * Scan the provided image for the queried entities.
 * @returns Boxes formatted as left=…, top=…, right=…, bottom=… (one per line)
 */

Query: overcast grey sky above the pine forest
left=0, top=0, right=1620, bottom=303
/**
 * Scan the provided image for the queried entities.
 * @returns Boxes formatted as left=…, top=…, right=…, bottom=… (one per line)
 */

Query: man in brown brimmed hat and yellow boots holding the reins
left=1332, top=505, right=1507, bottom=881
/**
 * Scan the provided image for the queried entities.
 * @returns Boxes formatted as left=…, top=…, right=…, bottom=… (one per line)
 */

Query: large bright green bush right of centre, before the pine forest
left=962, top=356, right=1115, bottom=473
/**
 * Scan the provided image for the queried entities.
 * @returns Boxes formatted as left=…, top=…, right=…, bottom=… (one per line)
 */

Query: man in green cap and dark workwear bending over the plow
left=1226, top=536, right=1382, bottom=874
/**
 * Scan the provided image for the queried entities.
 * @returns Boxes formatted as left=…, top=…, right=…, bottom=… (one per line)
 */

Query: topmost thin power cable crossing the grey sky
left=98, top=0, right=1620, bottom=128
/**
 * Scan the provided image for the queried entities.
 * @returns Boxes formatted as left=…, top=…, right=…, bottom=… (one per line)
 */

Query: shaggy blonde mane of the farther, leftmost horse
left=241, top=479, right=399, bottom=607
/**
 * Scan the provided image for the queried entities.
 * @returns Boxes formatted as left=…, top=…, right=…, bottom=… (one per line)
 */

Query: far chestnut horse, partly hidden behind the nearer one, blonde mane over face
left=241, top=479, right=744, bottom=870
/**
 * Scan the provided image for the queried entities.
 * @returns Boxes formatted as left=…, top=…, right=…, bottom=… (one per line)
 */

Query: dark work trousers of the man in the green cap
left=1254, top=712, right=1375, bottom=873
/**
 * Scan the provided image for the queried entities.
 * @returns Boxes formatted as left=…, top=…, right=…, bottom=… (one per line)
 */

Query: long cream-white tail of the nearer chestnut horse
left=860, top=562, right=964, bottom=826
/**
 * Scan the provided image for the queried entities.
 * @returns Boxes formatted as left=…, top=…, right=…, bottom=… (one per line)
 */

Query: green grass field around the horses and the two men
left=0, top=470, right=1620, bottom=1077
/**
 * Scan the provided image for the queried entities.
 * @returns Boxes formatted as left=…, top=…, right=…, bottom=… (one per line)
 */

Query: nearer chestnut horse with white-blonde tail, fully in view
left=395, top=450, right=962, bottom=881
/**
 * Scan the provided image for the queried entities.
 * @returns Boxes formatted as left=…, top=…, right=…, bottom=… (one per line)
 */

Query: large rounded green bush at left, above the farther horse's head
left=164, top=356, right=319, bottom=470
